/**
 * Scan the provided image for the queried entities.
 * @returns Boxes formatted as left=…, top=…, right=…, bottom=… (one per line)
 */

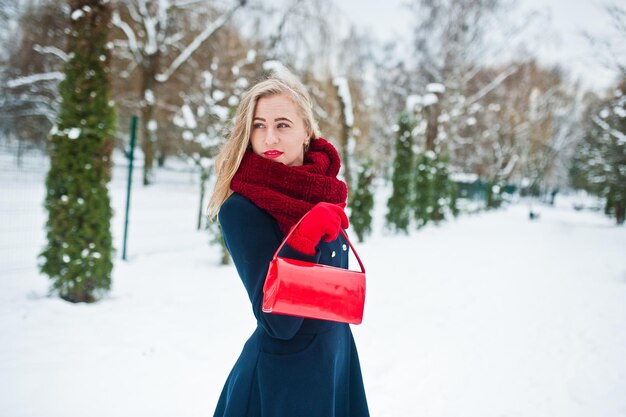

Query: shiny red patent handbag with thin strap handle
left=262, top=214, right=365, bottom=324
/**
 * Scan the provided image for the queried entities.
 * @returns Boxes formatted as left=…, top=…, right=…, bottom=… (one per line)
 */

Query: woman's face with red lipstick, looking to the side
left=250, top=94, right=309, bottom=166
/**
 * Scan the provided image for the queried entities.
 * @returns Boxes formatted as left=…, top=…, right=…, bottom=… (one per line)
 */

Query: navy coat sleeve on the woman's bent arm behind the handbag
left=218, top=194, right=319, bottom=339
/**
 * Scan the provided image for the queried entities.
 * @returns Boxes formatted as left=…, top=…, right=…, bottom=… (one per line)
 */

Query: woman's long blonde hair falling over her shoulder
left=207, top=69, right=318, bottom=219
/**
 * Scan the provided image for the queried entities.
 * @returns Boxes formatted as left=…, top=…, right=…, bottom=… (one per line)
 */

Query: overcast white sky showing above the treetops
left=334, top=0, right=614, bottom=90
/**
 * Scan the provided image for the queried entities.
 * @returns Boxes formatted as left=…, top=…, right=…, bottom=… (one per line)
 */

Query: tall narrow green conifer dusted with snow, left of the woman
left=40, top=0, right=115, bottom=302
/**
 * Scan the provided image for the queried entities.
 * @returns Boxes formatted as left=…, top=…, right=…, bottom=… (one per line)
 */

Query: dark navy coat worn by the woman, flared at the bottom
left=215, top=193, right=369, bottom=417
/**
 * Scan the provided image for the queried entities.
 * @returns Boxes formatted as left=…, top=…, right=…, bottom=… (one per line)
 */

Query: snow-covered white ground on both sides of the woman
left=0, top=157, right=626, bottom=417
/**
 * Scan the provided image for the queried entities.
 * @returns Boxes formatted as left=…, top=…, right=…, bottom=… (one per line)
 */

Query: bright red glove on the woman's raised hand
left=287, top=202, right=349, bottom=255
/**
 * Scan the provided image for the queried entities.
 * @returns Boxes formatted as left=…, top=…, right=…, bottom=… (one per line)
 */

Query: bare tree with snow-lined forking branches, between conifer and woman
left=113, top=0, right=246, bottom=185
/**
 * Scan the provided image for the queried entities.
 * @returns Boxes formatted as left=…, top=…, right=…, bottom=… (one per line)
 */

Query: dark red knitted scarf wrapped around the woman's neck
left=230, top=138, right=348, bottom=234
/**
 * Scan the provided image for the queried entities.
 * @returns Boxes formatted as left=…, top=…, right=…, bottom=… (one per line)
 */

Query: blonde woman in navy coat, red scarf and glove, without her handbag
left=209, top=70, right=369, bottom=417
